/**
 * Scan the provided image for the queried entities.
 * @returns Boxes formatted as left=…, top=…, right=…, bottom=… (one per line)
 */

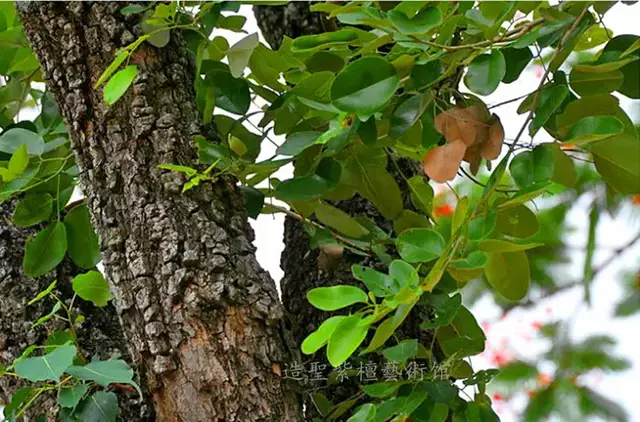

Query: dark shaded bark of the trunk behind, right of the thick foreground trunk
left=254, top=2, right=431, bottom=420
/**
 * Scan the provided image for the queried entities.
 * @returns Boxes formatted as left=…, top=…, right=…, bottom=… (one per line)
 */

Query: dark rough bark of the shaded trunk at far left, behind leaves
left=0, top=201, right=154, bottom=421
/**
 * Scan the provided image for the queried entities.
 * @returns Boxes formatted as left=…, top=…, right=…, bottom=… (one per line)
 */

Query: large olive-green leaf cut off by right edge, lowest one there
left=591, top=135, right=640, bottom=194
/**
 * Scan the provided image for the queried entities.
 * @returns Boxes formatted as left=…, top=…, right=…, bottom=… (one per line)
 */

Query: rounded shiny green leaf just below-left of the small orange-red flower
left=396, top=229, right=445, bottom=263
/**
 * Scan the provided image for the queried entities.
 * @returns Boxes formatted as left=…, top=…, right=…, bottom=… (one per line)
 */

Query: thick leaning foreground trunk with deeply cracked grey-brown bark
left=19, top=2, right=300, bottom=421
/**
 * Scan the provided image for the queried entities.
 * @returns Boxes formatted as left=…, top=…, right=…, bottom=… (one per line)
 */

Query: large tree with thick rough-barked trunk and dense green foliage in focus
left=0, top=2, right=640, bottom=421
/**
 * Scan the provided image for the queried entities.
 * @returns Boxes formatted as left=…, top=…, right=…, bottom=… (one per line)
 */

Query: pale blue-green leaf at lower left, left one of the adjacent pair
left=14, top=344, right=76, bottom=382
